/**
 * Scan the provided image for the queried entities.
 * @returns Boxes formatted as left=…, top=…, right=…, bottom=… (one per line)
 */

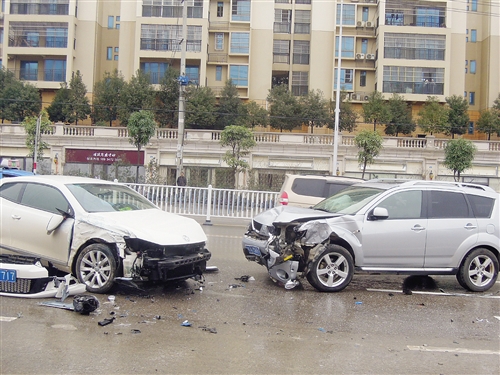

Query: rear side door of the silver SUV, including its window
left=425, top=190, right=478, bottom=268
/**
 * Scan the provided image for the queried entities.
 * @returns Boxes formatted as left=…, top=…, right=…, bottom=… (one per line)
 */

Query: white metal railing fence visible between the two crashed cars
left=125, top=183, right=279, bottom=224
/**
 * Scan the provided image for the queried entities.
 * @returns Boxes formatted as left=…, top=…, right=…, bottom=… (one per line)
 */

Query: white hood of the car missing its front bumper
left=78, top=209, right=207, bottom=246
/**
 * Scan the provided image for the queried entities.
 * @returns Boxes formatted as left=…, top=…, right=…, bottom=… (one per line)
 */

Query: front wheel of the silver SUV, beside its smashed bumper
left=307, top=245, right=354, bottom=292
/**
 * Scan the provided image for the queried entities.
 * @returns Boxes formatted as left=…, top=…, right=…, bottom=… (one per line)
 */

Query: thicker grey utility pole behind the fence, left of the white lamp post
left=175, top=0, right=189, bottom=181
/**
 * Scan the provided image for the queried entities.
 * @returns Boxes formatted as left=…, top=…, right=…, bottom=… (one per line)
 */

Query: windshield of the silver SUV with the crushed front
left=313, top=186, right=383, bottom=215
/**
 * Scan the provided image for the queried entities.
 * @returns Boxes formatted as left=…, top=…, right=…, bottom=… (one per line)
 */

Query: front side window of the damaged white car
left=21, top=184, right=70, bottom=214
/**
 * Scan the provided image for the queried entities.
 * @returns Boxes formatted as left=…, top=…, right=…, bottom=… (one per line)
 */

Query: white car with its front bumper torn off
left=0, top=175, right=211, bottom=293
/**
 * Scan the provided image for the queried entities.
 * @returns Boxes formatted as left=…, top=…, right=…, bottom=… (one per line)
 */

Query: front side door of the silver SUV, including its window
left=356, top=190, right=427, bottom=268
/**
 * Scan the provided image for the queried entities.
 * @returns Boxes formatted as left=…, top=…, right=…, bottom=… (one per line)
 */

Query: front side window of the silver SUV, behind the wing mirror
left=378, top=190, right=422, bottom=220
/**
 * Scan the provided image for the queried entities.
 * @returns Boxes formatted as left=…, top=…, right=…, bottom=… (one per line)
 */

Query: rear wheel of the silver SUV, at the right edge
left=457, top=248, right=498, bottom=292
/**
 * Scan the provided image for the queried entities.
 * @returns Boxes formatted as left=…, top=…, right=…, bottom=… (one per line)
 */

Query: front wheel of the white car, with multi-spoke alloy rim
left=75, top=243, right=117, bottom=293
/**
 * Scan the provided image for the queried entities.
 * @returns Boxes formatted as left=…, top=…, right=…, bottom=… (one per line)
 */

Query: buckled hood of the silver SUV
left=254, top=206, right=341, bottom=226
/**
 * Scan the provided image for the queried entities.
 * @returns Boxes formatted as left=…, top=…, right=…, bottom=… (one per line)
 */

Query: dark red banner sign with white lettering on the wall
left=66, top=148, right=144, bottom=165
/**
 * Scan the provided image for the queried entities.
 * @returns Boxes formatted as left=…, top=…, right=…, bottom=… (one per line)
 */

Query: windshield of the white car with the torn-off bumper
left=67, top=184, right=156, bottom=212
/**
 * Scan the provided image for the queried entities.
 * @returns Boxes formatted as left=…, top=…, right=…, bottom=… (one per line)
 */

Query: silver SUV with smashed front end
left=243, top=180, right=500, bottom=292
